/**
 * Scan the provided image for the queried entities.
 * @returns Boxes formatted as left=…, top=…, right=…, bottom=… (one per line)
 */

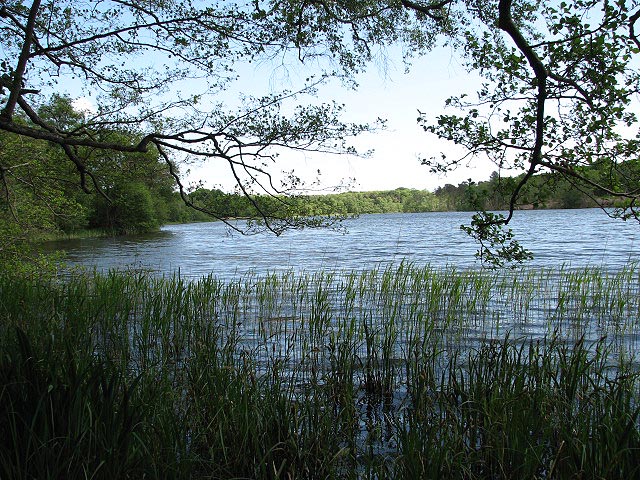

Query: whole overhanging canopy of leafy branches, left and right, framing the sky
left=0, top=0, right=640, bottom=264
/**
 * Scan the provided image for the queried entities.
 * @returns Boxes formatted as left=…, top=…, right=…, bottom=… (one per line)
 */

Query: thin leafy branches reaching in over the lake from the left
left=0, top=0, right=380, bottom=237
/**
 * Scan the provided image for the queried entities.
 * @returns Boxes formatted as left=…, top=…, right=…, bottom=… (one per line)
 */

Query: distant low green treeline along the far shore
left=182, top=172, right=603, bottom=221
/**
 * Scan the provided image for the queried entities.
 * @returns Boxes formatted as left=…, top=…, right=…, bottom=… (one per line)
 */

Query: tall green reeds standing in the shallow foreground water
left=0, top=262, right=640, bottom=480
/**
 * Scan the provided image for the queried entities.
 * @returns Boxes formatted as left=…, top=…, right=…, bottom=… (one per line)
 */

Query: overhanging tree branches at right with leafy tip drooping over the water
left=278, top=0, right=640, bottom=264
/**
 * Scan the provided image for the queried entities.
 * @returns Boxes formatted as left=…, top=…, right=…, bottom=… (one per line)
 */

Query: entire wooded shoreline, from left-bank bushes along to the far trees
left=0, top=96, right=624, bottom=244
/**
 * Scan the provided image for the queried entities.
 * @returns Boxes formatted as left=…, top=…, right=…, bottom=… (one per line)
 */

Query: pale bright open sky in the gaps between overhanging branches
left=188, top=47, right=495, bottom=191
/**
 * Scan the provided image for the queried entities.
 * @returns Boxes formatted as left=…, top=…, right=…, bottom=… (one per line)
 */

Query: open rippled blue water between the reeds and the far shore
left=43, top=209, right=640, bottom=278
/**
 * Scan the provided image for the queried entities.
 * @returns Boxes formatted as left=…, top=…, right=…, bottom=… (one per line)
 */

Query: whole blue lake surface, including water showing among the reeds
left=15, top=210, right=640, bottom=472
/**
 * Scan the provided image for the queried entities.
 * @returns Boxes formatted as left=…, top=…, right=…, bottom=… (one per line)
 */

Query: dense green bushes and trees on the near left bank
left=0, top=96, right=185, bottom=240
